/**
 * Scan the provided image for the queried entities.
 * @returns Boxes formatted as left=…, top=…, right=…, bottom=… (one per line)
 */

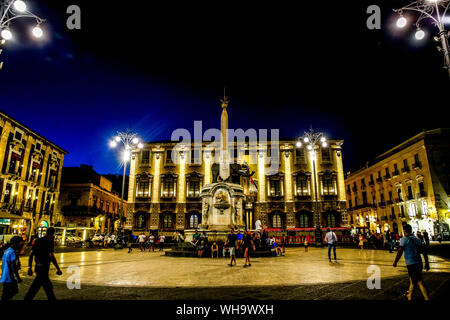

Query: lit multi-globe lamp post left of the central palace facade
left=109, top=129, right=144, bottom=236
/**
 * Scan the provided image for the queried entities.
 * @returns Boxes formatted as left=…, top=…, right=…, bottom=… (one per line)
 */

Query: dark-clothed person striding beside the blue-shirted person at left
left=24, top=227, right=62, bottom=300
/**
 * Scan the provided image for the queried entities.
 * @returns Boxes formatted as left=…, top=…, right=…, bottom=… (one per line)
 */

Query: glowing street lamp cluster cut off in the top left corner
left=0, top=0, right=45, bottom=70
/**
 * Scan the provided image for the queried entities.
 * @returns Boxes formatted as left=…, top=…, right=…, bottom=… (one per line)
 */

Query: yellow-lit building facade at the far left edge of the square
left=0, top=112, right=67, bottom=236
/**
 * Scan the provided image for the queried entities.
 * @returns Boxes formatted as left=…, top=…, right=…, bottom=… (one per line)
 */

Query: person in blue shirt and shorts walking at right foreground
left=393, top=224, right=430, bottom=300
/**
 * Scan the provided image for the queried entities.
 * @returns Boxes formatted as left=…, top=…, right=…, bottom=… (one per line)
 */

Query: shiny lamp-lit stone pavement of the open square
left=10, top=248, right=450, bottom=300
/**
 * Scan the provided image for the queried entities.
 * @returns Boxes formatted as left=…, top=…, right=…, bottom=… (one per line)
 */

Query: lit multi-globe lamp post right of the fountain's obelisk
left=296, top=128, right=328, bottom=246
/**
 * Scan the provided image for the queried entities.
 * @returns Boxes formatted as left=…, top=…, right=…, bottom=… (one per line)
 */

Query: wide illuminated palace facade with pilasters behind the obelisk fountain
left=125, top=101, right=346, bottom=235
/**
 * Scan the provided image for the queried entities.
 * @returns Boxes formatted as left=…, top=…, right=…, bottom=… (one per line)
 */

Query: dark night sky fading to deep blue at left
left=0, top=0, right=450, bottom=173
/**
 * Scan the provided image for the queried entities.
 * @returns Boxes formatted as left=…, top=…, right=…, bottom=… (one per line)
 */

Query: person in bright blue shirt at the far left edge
left=0, top=236, right=24, bottom=301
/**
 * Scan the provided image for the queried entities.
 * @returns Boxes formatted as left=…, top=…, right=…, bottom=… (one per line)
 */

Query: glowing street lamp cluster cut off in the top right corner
left=394, top=0, right=450, bottom=77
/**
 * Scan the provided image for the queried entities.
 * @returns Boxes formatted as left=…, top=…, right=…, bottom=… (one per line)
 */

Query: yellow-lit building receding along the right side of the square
left=345, top=129, right=450, bottom=236
